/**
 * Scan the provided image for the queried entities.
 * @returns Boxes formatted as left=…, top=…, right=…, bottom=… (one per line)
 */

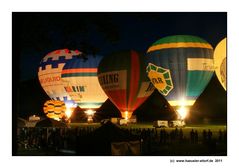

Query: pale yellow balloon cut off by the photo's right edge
left=214, top=38, right=227, bottom=90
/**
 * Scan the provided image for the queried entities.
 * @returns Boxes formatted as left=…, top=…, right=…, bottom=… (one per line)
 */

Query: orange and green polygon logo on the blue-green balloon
left=146, top=63, right=173, bottom=96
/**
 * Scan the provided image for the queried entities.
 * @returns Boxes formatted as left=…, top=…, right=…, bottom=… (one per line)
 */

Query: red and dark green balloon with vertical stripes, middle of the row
left=98, top=51, right=154, bottom=120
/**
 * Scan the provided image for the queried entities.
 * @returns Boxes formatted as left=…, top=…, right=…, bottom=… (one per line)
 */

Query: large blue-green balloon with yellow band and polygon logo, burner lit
left=146, top=35, right=214, bottom=119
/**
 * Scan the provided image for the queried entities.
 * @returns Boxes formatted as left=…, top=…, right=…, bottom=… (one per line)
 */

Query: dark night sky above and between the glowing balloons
left=12, top=12, right=227, bottom=121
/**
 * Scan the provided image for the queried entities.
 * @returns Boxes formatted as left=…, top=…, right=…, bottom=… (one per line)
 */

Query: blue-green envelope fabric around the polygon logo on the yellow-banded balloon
left=147, top=36, right=213, bottom=105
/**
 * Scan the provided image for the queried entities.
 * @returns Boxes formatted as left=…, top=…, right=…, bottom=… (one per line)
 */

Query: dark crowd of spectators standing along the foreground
left=17, top=127, right=227, bottom=155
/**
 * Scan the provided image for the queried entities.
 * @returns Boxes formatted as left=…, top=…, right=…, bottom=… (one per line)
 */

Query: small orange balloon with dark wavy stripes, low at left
left=43, top=100, right=66, bottom=121
